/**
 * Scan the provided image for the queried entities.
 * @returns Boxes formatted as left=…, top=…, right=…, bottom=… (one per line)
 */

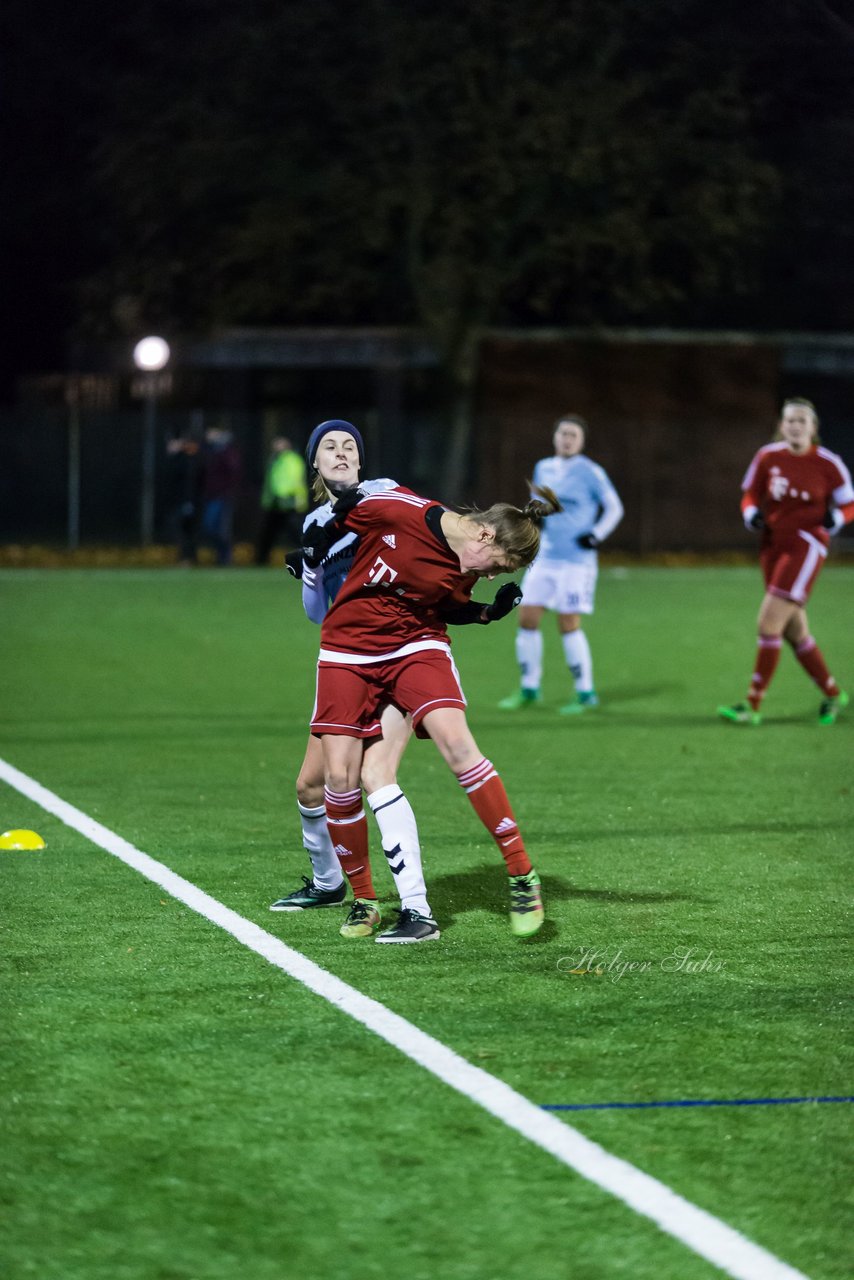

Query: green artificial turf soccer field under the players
left=0, top=567, right=854, bottom=1280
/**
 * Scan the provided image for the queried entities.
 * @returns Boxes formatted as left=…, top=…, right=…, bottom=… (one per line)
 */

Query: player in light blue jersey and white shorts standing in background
left=498, top=413, right=622, bottom=716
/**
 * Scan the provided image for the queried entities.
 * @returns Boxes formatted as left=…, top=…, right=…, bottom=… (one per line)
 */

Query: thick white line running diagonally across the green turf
left=0, top=759, right=807, bottom=1280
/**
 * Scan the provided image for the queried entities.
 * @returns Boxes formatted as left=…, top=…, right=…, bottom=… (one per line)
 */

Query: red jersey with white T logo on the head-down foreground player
left=320, top=488, right=476, bottom=662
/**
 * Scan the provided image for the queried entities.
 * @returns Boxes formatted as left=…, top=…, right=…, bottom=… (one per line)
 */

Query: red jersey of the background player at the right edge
left=741, top=440, right=854, bottom=544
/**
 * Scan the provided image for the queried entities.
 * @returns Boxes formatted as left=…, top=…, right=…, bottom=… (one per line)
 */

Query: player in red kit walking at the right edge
left=718, top=398, right=854, bottom=724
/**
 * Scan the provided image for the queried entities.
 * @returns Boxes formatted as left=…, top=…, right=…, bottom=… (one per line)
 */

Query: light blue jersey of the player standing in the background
left=534, top=453, right=622, bottom=564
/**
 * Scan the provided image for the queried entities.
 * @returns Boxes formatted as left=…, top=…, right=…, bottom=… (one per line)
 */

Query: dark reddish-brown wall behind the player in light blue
left=472, top=338, right=780, bottom=553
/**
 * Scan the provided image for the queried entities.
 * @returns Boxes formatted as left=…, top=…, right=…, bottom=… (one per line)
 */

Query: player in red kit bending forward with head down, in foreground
left=303, top=489, right=560, bottom=937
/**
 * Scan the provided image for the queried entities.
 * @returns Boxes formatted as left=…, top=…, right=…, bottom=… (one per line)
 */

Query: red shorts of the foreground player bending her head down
left=311, top=649, right=466, bottom=739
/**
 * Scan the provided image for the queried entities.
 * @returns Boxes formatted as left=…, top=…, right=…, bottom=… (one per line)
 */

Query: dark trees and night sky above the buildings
left=4, top=0, right=854, bottom=399
